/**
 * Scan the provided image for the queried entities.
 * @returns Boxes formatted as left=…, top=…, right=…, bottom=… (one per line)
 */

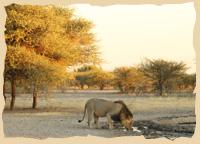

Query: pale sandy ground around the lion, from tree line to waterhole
left=3, top=92, right=195, bottom=139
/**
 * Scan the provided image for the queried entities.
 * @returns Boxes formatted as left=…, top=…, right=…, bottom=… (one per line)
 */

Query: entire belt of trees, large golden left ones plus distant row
left=4, top=4, right=196, bottom=110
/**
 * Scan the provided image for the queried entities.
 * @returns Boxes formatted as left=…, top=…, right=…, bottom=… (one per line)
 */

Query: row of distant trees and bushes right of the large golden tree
left=57, top=59, right=196, bottom=95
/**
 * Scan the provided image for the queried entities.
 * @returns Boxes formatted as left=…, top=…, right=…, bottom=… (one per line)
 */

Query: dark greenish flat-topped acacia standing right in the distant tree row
left=140, top=59, right=186, bottom=95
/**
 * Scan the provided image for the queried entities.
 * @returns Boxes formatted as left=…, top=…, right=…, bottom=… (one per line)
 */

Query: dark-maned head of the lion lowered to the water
left=115, top=101, right=133, bottom=130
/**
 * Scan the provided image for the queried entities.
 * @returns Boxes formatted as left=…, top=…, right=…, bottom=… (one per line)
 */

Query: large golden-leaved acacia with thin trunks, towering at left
left=5, top=4, right=99, bottom=109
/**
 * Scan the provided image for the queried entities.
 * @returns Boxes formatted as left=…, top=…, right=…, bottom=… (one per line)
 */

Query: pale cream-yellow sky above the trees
left=71, top=3, right=196, bottom=73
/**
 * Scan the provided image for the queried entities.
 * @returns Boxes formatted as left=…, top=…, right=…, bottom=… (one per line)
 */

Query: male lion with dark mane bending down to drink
left=78, top=98, right=133, bottom=130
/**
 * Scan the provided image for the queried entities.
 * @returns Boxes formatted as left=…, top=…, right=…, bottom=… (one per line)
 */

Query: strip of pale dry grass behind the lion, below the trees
left=5, top=91, right=195, bottom=117
